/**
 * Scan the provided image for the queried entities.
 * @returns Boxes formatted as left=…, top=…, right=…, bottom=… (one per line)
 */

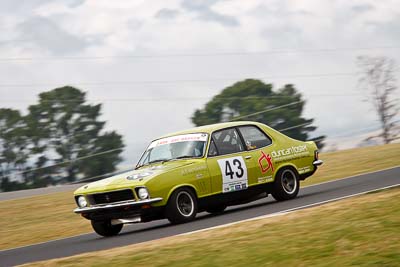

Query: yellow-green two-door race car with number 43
left=74, top=121, right=322, bottom=236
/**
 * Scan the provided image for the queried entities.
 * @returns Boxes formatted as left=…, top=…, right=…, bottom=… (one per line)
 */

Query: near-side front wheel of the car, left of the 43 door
left=165, top=188, right=197, bottom=224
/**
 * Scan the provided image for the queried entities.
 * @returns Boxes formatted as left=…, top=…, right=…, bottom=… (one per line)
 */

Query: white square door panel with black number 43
left=218, top=157, right=247, bottom=184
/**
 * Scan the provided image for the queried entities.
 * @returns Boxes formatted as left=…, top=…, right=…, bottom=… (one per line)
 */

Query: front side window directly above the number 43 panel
left=209, top=128, right=244, bottom=156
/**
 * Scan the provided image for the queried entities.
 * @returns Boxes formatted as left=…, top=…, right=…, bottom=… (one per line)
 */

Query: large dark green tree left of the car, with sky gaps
left=27, top=86, right=123, bottom=182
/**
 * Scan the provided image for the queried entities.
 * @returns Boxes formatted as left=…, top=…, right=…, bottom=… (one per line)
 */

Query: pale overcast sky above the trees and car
left=0, top=0, right=400, bottom=168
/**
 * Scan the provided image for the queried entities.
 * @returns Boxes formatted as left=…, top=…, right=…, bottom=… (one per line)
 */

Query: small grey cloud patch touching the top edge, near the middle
left=182, top=0, right=239, bottom=27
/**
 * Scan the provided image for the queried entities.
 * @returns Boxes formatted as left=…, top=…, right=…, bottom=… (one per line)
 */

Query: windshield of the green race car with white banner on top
left=137, top=133, right=208, bottom=167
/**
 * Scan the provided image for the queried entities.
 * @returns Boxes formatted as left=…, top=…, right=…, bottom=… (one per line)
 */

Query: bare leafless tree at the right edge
left=357, top=56, right=399, bottom=144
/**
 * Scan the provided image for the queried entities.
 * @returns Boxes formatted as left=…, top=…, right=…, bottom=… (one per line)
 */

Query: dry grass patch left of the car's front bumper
left=0, top=192, right=92, bottom=251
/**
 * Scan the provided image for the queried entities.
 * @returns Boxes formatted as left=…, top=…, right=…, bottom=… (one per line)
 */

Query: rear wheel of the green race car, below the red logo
left=271, top=168, right=300, bottom=201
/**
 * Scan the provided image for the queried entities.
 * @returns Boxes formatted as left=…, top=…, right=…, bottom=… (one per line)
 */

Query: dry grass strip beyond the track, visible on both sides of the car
left=0, top=144, right=400, bottom=252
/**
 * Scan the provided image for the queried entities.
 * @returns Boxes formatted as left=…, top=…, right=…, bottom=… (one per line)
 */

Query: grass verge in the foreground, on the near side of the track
left=23, top=188, right=400, bottom=266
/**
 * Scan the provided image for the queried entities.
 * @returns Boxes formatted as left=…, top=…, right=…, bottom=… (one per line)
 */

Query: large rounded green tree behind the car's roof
left=192, top=79, right=325, bottom=148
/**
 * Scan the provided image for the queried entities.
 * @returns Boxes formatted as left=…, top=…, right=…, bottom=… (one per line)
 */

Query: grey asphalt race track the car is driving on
left=0, top=167, right=400, bottom=266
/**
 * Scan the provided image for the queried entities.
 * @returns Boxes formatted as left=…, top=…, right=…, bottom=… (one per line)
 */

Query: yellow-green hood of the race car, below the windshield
left=74, top=160, right=194, bottom=195
